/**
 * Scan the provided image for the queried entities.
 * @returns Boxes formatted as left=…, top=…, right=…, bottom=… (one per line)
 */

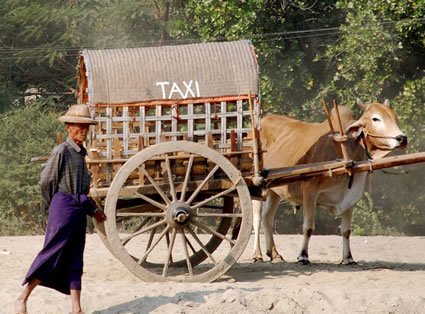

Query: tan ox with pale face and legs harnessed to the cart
left=253, top=100, right=407, bottom=264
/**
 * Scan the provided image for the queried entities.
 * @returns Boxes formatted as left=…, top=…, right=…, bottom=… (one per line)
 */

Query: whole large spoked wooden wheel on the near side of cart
left=105, top=141, right=252, bottom=282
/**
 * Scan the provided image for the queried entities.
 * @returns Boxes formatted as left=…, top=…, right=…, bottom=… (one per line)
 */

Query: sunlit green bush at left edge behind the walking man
left=0, top=99, right=63, bottom=235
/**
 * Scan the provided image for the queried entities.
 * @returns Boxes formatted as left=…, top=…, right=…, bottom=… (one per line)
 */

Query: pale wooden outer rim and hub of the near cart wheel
left=105, top=141, right=252, bottom=282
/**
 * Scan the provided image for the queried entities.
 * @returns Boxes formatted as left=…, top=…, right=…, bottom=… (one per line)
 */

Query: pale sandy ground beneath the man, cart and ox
left=0, top=234, right=425, bottom=314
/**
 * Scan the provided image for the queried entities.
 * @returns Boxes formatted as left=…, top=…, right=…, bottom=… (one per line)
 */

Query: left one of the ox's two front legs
left=297, top=188, right=317, bottom=265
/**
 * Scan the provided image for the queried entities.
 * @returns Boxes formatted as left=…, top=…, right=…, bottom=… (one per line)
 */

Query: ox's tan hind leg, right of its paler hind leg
left=262, top=191, right=284, bottom=263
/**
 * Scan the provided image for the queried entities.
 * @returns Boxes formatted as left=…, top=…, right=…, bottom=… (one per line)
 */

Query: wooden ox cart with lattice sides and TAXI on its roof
left=78, top=41, right=425, bottom=282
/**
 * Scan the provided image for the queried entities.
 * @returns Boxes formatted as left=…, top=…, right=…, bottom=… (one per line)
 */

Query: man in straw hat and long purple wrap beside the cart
left=15, top=105, right=106, bottom=313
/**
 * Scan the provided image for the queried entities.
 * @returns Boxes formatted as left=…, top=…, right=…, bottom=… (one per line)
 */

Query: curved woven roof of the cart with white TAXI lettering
left=78, top=40, right=259, bottom=105
